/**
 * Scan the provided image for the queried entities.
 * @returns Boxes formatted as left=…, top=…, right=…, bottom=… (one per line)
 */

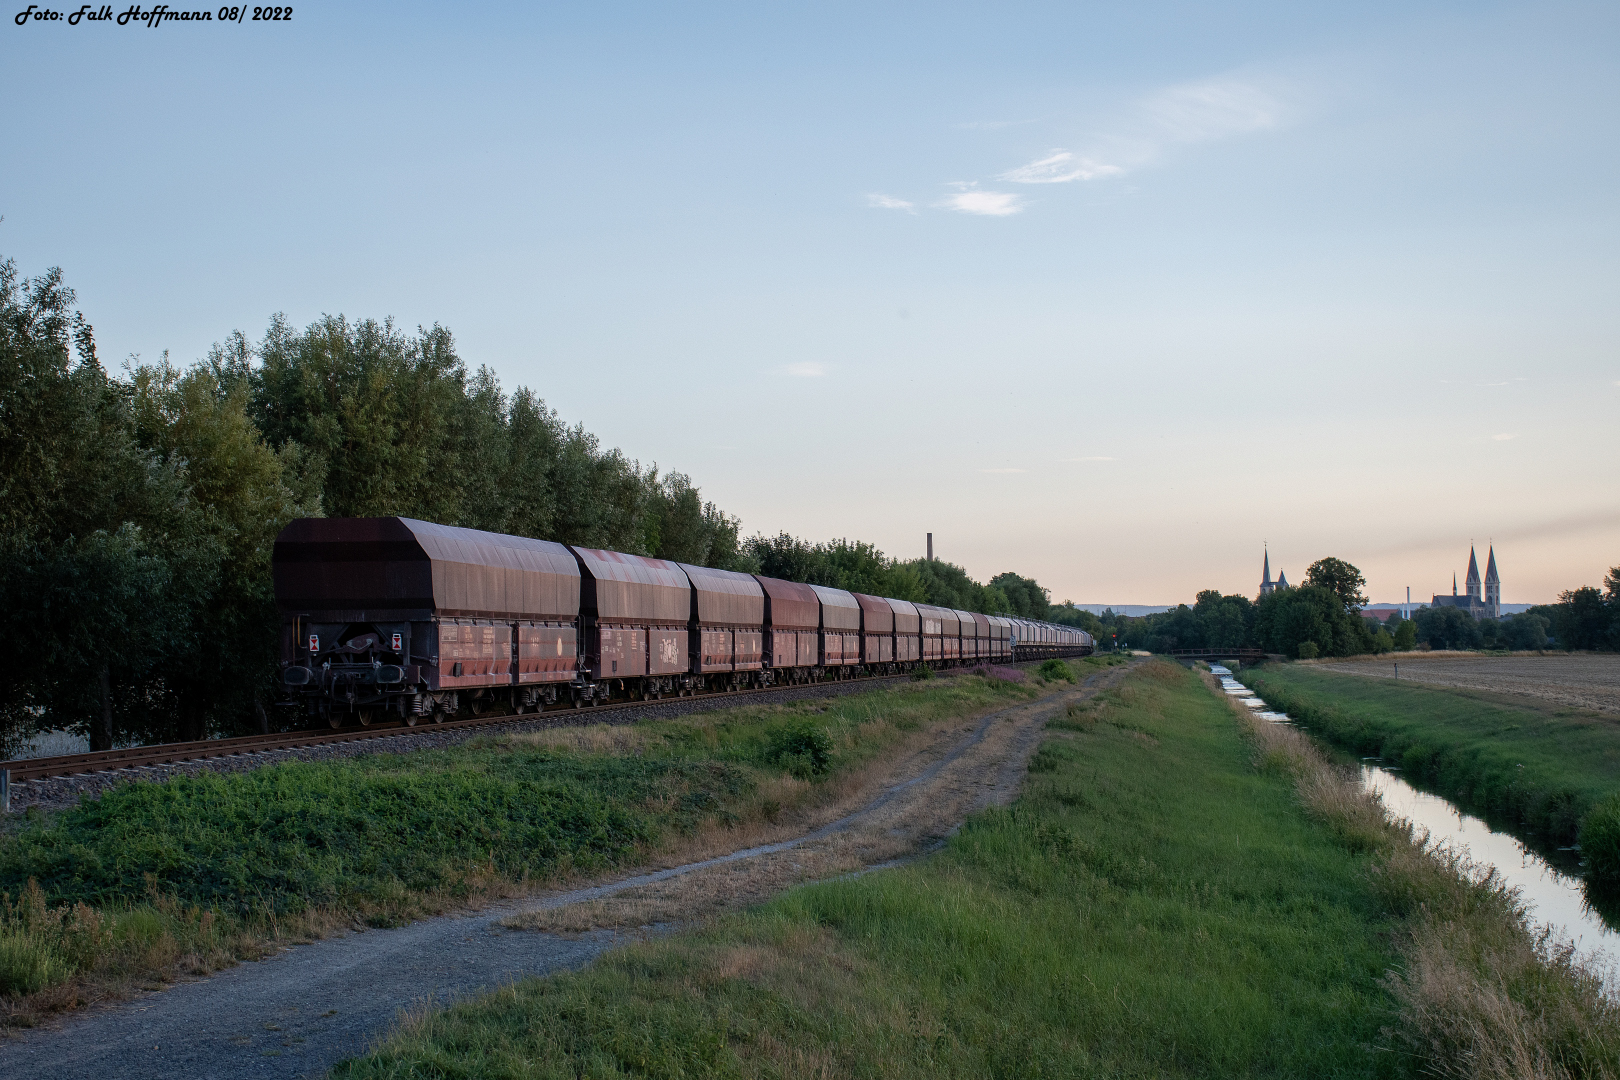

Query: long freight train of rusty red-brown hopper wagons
left=271, top=518, right=1094, bottom=727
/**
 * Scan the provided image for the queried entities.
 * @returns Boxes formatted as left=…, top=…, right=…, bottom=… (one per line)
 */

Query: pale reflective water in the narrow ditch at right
left=1210, top=664, right=1620, bottom=960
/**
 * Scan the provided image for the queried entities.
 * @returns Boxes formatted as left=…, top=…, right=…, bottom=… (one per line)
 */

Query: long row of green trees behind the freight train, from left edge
left=0, top=259, right=1048, bottom=751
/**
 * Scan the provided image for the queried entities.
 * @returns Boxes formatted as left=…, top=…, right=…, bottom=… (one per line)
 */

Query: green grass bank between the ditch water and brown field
left=1241, top=664, right=1620, bottom=884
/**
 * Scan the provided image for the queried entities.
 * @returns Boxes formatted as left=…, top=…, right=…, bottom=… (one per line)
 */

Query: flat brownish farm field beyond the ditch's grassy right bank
left=1304, top=653, right=1620, bottom=712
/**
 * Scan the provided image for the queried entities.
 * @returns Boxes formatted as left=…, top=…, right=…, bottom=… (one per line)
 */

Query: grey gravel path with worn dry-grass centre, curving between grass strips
left=0, top=669, right=1124, bottom=1080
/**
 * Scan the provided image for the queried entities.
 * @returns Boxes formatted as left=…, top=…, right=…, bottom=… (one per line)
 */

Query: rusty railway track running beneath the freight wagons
left=0, top=675, right=904, bottom=784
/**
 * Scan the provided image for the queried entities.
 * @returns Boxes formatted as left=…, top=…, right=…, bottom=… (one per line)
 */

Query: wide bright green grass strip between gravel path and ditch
left=335, top=662, right=1403, bottom=1080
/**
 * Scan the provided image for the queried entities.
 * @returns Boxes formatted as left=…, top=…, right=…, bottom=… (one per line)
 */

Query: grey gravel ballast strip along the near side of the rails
left=11, top=675, right=909, bottom=813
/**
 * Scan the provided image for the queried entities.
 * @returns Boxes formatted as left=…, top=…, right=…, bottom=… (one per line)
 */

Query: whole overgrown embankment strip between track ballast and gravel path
left=0, top=677, right=1042, bottom=1023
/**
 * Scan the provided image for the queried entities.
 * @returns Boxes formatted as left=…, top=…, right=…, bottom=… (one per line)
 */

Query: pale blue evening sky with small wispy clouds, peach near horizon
left=0, top=0, right=1620, bottom=604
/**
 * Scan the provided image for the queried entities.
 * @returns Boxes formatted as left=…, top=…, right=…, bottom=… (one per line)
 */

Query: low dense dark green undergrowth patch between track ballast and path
left=0, top=750, right=709, bottom=912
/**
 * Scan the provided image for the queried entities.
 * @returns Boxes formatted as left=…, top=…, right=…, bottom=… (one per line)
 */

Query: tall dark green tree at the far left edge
left=0, top=259, right=219, bottom=750
